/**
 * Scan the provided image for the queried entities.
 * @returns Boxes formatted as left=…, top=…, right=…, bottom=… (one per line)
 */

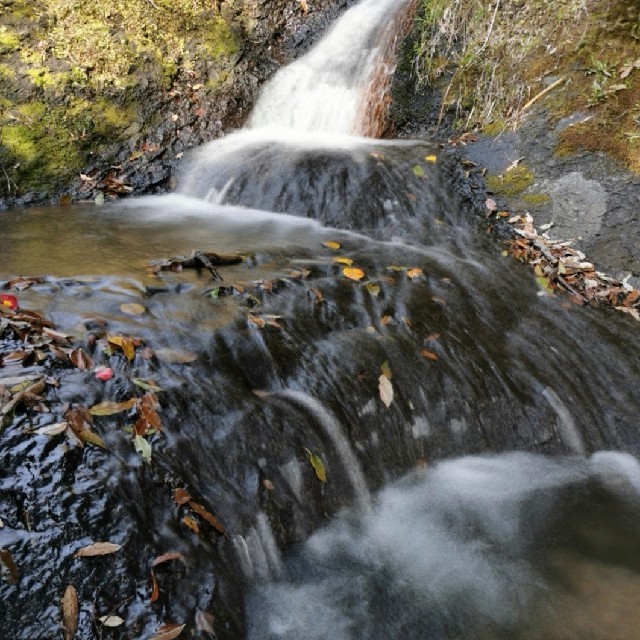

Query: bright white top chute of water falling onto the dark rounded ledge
left=249, top=0, right=409, bottom=135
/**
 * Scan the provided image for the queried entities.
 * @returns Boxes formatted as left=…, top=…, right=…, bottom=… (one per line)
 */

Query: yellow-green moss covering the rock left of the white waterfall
left=0, top=0, right=239, bottom=195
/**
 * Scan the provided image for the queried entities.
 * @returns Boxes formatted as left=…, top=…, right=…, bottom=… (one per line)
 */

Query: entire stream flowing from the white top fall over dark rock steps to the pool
left=0, top=0, right=640, bottom=640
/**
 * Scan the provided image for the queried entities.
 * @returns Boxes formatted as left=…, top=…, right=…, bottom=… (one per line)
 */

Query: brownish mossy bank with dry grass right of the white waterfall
left=414, top=0, right=640, bottom=171
